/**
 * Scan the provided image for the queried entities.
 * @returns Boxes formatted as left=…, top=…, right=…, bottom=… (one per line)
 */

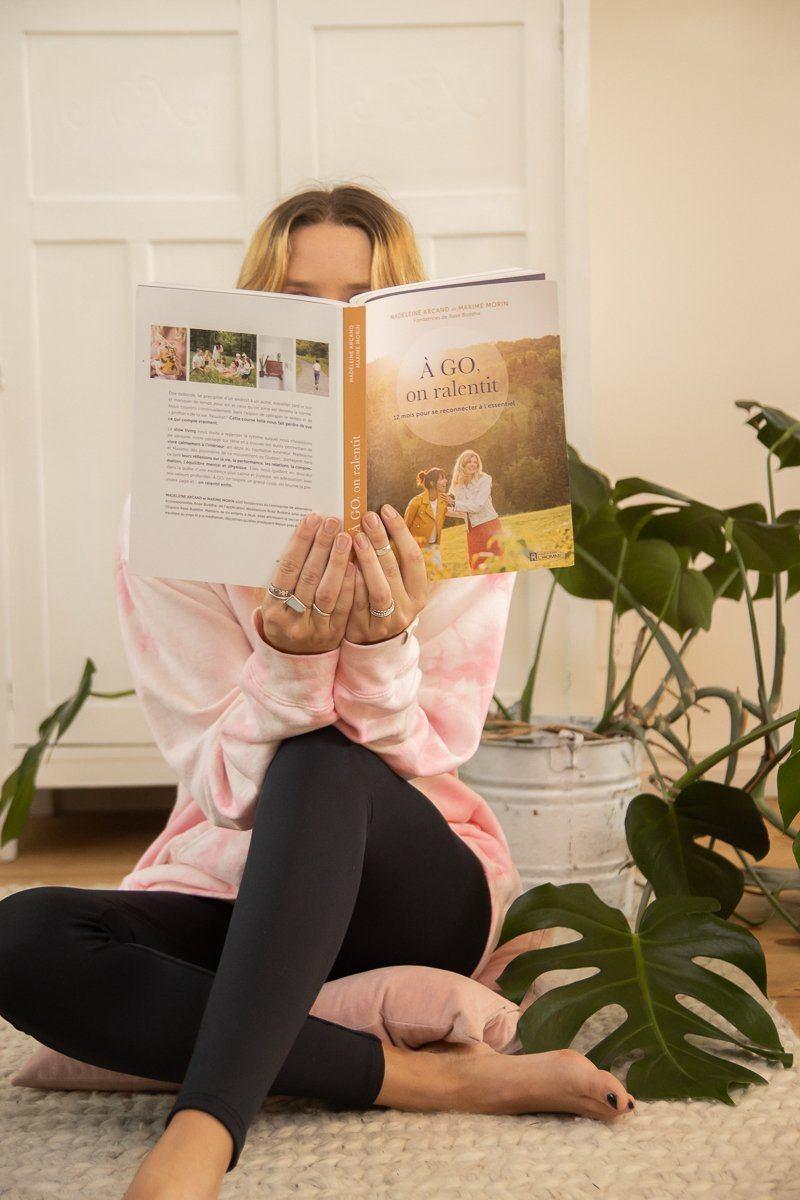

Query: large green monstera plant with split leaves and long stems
left=493, top=400, right=800, bottom=1104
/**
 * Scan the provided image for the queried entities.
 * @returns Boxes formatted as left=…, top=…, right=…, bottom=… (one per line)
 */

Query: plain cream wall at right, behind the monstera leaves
left=582, top=0, right=800, bottom=777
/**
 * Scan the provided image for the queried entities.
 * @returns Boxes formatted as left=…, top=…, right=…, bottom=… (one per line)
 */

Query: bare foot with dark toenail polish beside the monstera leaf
left=427, top=1043, right=634, bottom=1121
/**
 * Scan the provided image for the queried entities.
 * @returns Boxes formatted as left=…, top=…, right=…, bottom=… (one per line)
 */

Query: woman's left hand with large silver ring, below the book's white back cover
left=261, top=512, right=355, bottom=654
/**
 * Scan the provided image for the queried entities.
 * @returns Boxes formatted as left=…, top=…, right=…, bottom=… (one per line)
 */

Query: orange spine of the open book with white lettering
left=342, top=305, right=367, bottom=534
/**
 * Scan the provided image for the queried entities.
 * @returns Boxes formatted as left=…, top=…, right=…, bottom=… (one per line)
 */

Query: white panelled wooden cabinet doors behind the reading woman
left=0, top=0, right=594, bottom=786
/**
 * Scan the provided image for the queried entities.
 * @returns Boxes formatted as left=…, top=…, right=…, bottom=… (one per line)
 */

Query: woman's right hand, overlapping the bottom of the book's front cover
left=344, top=504, right=429, bottom=646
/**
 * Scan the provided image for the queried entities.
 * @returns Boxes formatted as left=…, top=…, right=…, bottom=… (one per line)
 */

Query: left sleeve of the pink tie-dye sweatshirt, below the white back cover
left=115, top=502, right=339, bottom=829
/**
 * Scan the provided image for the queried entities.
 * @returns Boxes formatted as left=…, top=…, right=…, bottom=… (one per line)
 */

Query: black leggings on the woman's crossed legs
left=0, top=726, right=491, bottom=1171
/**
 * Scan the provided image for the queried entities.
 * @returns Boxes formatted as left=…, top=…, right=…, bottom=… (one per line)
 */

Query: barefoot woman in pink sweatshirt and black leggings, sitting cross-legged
left=0, top=186, right=630, bottom=1200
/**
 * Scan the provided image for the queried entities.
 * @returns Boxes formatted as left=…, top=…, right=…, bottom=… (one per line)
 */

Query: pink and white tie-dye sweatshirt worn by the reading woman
left=115, top=496, right=522, bottom=976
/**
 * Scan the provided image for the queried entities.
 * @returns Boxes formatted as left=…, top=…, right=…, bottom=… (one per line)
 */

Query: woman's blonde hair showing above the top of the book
left=236, top=184, right=427, bottom=292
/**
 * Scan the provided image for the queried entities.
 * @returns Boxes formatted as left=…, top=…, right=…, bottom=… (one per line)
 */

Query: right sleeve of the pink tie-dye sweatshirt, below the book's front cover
left=333, top=572, right=517, bottom=779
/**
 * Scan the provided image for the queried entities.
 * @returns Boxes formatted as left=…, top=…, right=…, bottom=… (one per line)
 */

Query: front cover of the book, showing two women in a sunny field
left=365, top=274, right=575, bottom=578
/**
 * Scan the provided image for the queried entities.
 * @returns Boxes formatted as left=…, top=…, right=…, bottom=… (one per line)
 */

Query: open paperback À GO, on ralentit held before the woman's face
left=130, top=268, right=573, bottom=588
